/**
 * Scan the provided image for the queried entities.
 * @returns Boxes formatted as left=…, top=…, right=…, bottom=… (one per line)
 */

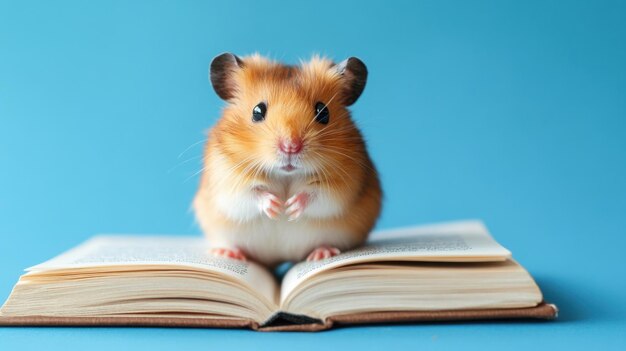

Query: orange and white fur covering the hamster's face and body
left=194, top=55, right=382, bottom=265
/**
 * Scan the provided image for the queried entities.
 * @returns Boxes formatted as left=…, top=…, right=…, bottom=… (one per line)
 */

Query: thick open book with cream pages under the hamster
left=0, top=221, right=556, bottom=330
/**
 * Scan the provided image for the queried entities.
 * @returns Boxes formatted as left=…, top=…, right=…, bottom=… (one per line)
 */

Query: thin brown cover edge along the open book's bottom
left=0, top=302, right=558, bottom=331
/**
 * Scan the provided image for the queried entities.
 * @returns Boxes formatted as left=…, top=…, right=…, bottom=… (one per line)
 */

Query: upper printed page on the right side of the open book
left=281, top=220, right=511, bottom=301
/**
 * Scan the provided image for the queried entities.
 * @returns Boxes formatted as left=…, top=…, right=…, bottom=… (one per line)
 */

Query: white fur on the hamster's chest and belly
left=207, top=172, right=356, bottom=265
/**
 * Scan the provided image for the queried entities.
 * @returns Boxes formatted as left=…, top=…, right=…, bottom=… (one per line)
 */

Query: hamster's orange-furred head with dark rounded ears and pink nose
left=210, top=53, right=367, bottom=180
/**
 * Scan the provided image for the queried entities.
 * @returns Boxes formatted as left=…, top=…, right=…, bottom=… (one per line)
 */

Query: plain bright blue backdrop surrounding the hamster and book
left=0, top=1, right=626, bottom=350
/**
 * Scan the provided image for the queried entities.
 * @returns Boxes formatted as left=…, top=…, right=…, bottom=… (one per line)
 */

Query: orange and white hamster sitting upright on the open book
left=193, top=53, right=382, bottom=267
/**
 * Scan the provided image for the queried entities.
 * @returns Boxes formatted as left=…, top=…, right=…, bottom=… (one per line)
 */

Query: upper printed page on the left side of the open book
left=26, top=235, right=278, bottom=303
